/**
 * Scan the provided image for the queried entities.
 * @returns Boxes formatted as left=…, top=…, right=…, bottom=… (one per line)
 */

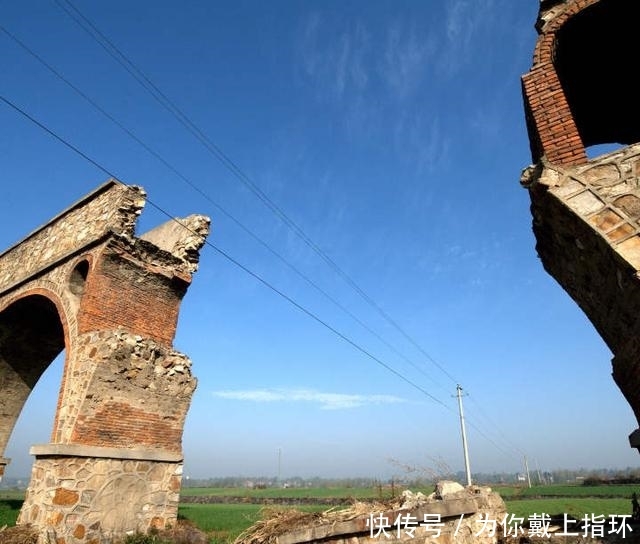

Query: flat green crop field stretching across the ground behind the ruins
left=0, top=485, right=638, bottom=544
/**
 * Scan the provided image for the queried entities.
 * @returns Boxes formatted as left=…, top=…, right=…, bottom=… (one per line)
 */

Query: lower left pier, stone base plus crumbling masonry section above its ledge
left=18, top=330, right=196, bottom=544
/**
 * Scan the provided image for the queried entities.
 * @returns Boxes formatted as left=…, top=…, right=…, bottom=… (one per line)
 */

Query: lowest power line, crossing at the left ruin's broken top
left=0, top=95, right=453, bottom=411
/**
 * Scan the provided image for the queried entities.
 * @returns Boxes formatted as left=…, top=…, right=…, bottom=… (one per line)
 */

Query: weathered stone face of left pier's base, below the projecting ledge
left=18, top=451, right=181, bottom=544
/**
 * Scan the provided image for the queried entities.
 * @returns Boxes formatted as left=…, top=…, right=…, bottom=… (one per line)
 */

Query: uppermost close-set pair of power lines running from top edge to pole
left=54, top=0, right=457, bottom=384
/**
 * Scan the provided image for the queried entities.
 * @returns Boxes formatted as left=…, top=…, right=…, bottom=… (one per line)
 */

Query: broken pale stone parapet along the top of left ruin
left=0, top=179, right=210, bottom=295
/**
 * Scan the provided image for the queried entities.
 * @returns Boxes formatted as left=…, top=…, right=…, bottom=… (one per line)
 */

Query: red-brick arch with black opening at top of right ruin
left=522, top=0, right=640, bottom=165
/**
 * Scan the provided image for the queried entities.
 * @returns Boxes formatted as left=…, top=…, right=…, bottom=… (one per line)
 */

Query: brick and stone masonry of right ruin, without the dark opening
left=521, top=0, right=640, bottom=447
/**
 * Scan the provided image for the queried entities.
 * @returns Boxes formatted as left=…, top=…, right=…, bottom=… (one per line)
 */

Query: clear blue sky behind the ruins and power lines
left=0, top=0, right=639, bottom=477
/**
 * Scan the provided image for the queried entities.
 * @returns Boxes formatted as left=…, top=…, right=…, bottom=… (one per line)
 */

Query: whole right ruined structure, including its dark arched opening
left=522, top=0, right=640, bottom=448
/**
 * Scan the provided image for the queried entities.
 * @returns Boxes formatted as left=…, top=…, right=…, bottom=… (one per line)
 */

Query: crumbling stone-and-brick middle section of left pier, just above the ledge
left=62, top=331, right=196, bottom=453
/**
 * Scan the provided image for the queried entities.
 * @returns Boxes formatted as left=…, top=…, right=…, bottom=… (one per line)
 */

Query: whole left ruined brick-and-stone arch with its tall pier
left=0, top=180, right=209, bottom=544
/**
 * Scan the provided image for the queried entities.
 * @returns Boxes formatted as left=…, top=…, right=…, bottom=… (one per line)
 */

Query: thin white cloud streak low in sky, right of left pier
left=213, top=389, right=405, bottom=410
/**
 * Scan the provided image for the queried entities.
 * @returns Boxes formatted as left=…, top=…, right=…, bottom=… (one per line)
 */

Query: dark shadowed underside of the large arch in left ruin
left=0, top=295, right=65, bottom=470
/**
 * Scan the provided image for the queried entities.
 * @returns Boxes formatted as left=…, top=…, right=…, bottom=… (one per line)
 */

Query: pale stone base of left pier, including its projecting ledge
left=18, top=444, right=182, bottom=544
